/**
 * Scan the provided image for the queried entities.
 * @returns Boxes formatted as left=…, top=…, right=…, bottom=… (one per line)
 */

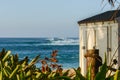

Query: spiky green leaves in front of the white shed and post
left=73, top=53, right=120, bottom=80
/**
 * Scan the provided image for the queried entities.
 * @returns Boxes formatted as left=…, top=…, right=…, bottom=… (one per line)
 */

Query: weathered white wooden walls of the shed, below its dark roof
left=79, top=21, right=120, bottom=75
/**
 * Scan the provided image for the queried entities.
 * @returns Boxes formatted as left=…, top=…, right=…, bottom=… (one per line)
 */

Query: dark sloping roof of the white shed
left=78, top=10, right=120, bottom=24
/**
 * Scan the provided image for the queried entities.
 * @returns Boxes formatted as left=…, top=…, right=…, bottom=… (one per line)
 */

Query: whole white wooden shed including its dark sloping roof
left=78, top=10, right=120, bottom=75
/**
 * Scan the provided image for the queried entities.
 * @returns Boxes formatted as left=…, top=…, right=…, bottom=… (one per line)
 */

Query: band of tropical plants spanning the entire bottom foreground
left=0, top=49, right=120, bottom=80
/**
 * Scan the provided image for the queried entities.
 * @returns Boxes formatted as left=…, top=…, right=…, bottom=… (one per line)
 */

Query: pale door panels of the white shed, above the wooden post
left=86, top=27, right=108, bottom=58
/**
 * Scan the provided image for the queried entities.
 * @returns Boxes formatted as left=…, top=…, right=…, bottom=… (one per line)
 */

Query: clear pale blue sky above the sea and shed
left=0, top=0, right=118, bottom=37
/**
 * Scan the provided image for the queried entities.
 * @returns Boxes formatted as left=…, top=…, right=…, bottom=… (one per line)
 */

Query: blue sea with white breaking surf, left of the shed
left=0, top=38, right=79, bottom=68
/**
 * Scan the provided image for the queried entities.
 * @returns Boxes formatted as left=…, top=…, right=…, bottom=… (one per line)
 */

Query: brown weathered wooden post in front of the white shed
left=85, top=49, right=102, bottom=80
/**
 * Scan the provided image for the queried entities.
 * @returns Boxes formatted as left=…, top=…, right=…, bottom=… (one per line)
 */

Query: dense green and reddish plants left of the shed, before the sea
left=0, top=49, right=70, bottom=80
